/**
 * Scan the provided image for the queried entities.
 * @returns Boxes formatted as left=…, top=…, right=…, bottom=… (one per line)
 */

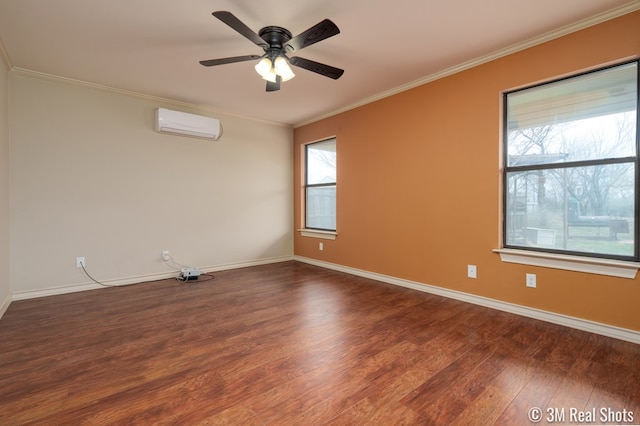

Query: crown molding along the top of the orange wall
left=293, top=0, right=640, bottom=129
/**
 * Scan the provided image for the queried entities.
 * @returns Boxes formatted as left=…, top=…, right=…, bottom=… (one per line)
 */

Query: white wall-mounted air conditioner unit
left=156, top=108, right=222, bottom=141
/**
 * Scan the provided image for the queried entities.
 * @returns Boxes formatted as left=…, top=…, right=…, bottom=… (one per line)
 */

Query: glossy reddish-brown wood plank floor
left=0, top=262, right=640, bottom=425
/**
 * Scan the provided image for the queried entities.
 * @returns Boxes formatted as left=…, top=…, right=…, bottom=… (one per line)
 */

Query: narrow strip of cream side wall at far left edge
left=0, top=55, right=11, bottom=316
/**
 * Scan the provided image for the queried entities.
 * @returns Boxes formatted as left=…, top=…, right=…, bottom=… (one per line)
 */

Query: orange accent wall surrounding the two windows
left=294, top=12, right=640, bottom=331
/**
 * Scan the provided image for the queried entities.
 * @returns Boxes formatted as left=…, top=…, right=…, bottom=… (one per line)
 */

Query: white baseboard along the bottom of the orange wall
left=294, top=256, right=640, bottom=344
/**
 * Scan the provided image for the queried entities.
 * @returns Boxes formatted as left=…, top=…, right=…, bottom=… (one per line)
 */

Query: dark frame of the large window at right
left=496, top=59, right=640, bottom=262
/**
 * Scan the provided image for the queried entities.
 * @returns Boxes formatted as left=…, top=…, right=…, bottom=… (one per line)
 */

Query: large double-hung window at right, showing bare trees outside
left=503, top=61, right=638, bottom=261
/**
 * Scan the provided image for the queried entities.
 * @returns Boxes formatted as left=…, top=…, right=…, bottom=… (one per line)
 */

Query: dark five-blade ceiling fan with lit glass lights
left=200, top=11, right=344, bottom=92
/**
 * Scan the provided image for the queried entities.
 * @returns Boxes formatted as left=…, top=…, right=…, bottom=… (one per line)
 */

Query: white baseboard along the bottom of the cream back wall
left=7, top=256, right=293, bottom=306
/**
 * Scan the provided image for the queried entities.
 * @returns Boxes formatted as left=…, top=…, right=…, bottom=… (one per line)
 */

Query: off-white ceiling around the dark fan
left=0, top=0, right=640, bottom=126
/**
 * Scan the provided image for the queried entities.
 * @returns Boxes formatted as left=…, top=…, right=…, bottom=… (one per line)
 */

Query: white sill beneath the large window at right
left=493, top=249, right=640, bottom=279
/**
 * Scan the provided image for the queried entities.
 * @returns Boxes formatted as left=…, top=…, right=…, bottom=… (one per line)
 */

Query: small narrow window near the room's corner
left=305, top=138, right=336, bottom=231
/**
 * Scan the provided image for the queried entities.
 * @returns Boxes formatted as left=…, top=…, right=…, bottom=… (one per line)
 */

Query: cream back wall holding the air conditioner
left=9, top=71, right=293, bottom=299
